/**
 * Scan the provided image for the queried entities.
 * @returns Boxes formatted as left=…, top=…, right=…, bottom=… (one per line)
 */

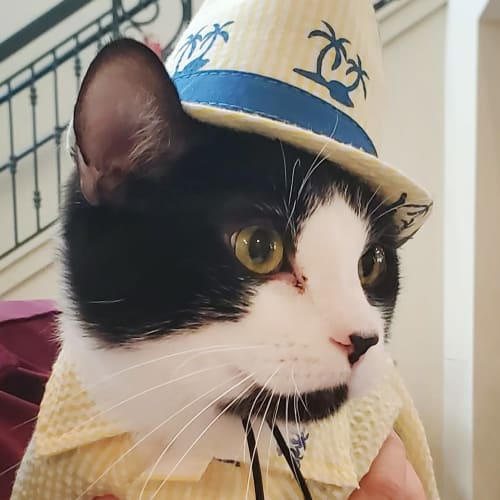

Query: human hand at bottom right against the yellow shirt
left=349, top=432, right=426, bottom=500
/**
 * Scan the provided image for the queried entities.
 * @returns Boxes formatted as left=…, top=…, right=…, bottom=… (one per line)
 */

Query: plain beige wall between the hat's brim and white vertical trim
left=380, top=3, right=446, bottom=490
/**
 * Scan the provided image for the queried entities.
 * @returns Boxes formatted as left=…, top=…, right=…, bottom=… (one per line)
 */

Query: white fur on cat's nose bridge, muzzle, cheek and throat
left=62, top=196, right=387, bottom=474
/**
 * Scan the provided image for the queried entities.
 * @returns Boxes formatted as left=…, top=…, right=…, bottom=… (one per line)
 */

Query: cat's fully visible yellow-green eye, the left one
left=232, top=226, right=284, bottom=274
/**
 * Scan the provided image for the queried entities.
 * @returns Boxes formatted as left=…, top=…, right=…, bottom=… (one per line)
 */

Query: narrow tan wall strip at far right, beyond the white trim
left=474, top=16, right=500, bottom=500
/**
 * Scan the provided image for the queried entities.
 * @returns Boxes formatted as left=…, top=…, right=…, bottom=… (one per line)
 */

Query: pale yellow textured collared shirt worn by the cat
left=11, top=351, right=439, bottom=500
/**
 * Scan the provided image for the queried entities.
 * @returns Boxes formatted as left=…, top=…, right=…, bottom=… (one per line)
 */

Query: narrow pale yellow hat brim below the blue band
left=182, top=102, right=432, bottom=244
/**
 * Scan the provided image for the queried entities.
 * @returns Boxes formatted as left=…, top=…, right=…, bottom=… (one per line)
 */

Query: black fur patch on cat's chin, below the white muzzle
left=220, top=384, right=349, bottom=422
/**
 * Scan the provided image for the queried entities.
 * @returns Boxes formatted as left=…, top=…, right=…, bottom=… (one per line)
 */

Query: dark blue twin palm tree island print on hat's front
left=293, top=21, right=370, bottom=108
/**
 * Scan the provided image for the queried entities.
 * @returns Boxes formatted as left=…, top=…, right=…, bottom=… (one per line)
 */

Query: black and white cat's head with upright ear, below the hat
left=63, top=40, right=399, bottom=430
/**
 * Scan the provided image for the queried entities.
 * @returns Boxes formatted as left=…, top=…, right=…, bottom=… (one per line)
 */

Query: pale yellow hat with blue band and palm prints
left=166, top=0, right=432, bottom=244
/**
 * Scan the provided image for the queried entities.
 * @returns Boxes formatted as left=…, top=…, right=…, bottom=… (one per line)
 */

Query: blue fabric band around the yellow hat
left=173, top=70, right=377, bottom=156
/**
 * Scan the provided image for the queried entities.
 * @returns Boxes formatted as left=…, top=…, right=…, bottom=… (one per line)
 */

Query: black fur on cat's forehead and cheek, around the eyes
left=63, top=126, right=398, bottom=345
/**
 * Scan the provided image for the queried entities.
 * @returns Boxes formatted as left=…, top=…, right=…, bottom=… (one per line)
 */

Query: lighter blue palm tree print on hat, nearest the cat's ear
left=175, top=21, right=234, bottom=75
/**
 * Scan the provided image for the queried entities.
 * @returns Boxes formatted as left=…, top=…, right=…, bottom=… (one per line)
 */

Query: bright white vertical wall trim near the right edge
left=443, top=0, right=490, bottom=500
